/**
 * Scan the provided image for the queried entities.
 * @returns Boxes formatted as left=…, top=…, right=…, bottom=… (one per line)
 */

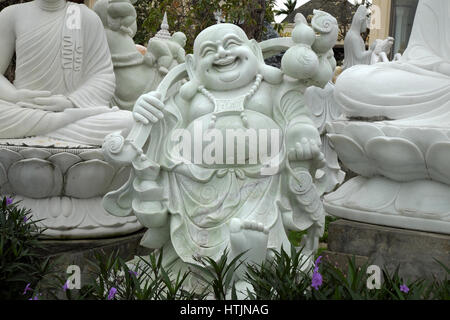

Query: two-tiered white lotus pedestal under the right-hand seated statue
left=324, top=121, right=450, bottom=234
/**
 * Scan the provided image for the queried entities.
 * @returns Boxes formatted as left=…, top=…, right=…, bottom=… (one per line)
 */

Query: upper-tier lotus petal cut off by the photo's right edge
left=426, top=142, right=450, bottom=185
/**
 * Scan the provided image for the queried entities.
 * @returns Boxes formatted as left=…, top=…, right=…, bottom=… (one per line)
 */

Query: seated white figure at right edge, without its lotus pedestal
left=335, top=0, right=450, bottom=127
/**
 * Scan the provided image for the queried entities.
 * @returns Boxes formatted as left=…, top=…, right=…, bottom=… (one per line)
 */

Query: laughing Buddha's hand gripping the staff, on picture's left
left=133, top=91, right=164, bottom=124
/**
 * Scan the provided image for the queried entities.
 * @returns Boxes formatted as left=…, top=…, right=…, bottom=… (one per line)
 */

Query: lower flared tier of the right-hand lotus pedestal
left=324, top=176, right=450, bottom=235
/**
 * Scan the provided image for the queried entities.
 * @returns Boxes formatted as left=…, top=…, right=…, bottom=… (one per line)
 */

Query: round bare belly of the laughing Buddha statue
left=178, top=110, right=283, bottom=167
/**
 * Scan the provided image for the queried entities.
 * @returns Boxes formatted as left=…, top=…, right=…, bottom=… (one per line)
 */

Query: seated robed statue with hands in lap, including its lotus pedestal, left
left=0, top=0, right=141, bottom=238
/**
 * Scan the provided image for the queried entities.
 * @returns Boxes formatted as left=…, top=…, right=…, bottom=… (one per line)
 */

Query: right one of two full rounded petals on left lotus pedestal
left=65, top=160, right=114, bottom=199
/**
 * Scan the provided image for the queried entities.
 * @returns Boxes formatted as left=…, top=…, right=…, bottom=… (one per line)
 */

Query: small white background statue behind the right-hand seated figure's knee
left=342, top=5, right=394, bottom=70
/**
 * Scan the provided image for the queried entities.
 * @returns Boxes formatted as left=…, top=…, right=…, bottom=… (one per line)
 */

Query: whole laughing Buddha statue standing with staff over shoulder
left=103, top=11, right=337, bottom=296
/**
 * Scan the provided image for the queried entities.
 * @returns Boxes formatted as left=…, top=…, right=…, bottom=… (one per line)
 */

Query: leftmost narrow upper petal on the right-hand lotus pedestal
left=328, top=134, right=377, bottom=177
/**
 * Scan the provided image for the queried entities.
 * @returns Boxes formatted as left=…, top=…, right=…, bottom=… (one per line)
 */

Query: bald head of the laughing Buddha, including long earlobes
left=182, top=23, right=281, bottom=97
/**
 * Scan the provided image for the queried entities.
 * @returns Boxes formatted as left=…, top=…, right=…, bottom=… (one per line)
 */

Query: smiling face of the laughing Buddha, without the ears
left=194, top=24, right=258, bottom=91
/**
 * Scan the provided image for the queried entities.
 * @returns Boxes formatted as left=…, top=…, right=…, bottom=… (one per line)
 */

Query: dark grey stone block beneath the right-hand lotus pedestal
left=324, top=219, right=450, bottom=280
